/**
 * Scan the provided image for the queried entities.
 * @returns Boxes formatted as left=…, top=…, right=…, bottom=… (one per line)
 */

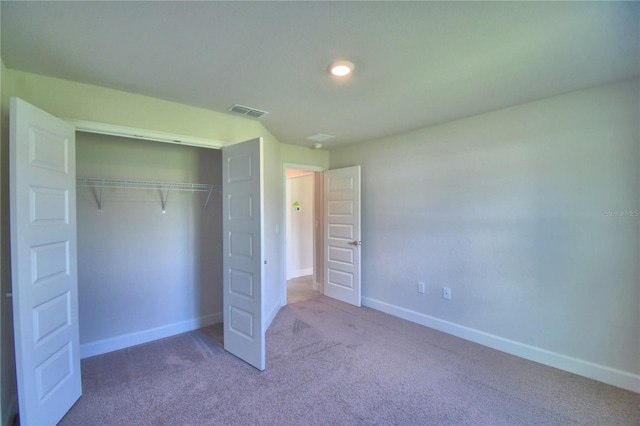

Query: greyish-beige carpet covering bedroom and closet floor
left=60, top=296, right=640, bottom=426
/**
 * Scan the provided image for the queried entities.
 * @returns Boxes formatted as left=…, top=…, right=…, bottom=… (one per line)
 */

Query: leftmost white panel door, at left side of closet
left=10, top=98, right=82, bottom=425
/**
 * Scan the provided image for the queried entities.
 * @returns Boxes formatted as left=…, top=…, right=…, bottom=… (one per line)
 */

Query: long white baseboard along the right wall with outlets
left=362, top=297, right=640, bottom=393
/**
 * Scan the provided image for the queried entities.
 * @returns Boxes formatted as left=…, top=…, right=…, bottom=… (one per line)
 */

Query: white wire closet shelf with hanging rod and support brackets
left=76, top=177, right=222, bottom=213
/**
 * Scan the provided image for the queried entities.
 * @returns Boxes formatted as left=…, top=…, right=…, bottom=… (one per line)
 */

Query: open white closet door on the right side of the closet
left=222, top=139, right=265, bottom=370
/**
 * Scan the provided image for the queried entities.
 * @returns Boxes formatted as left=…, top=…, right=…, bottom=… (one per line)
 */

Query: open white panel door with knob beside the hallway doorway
left=324, top=166, right=362, bottom=306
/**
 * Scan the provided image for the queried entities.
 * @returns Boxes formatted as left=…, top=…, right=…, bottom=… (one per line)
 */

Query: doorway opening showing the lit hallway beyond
left=283, top=166, right=323, bottom=304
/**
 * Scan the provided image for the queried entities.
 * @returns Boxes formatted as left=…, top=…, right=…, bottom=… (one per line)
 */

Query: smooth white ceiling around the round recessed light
left=1, top=0, right=640, bottom=148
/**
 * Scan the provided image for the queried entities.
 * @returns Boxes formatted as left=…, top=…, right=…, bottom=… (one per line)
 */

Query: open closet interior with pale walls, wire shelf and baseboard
left=76, top=132, right=222, bottom=357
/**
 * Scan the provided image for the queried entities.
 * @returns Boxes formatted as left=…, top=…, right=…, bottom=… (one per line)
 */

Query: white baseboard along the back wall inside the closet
left=80, top=312, right=222, bottom=358
